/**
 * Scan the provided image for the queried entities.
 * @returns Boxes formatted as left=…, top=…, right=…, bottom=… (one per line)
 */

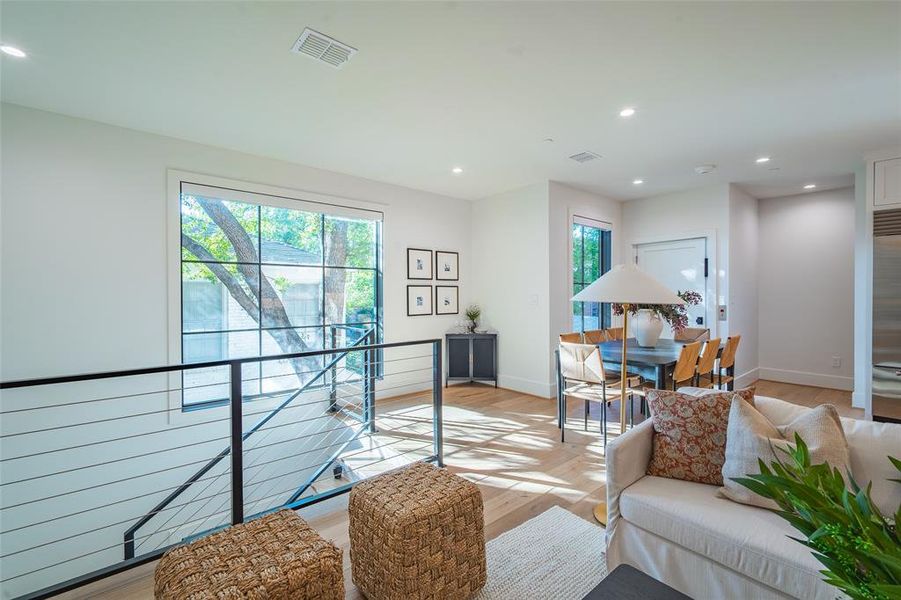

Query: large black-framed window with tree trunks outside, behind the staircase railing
left=179, top=182, right=382, bottom=408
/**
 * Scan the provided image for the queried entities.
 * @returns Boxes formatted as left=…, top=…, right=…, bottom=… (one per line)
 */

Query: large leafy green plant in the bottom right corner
left=733, top=434, right=901, bottom=600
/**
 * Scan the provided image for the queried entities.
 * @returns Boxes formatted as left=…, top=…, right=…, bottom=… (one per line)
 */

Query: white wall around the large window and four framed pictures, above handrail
left=0, top=104, right=473, bottom=380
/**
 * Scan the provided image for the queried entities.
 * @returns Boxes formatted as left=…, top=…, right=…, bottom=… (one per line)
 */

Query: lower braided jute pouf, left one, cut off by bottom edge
left=154, top=510, right=344, bottom=600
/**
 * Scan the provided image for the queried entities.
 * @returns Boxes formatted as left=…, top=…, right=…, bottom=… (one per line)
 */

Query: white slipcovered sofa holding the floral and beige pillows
left=607, top=396, right=901, bottom=600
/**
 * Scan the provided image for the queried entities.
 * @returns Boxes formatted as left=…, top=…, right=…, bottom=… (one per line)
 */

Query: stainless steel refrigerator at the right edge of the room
left=873, top=210, right=901, bottom=423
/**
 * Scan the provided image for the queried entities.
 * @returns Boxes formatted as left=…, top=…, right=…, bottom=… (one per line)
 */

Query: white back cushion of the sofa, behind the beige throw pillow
left=754, top=396, right=901, bottom=515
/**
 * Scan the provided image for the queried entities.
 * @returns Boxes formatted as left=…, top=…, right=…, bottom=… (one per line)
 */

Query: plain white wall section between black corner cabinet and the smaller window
left=470, top=182, right=553, bottom=397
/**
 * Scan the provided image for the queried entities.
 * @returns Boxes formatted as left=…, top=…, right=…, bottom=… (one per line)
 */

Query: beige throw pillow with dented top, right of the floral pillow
left=720, top=397, right=851, bottom=508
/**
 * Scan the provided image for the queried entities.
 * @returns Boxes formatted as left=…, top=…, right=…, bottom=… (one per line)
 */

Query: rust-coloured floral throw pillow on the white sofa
left=648, top=388, right=754, bottom=485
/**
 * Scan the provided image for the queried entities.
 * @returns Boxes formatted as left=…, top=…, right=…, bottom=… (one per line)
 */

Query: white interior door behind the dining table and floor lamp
left=634, top=238, right=711, bottom=338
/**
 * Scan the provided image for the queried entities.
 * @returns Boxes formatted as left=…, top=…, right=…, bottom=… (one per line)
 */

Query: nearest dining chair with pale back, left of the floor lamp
left=559, top=342, right=639, bottom=448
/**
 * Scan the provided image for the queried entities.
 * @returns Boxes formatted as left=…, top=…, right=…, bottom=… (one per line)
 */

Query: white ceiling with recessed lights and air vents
left=0, top=0, right=901, bottom=199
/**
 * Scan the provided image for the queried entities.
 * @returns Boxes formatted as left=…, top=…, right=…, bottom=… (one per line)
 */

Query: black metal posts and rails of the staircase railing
left=0, top=329, right=443, bottom=600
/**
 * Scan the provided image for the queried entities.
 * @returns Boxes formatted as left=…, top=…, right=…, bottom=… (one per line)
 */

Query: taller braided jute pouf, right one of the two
left=349, top=463, right=487, bottom=600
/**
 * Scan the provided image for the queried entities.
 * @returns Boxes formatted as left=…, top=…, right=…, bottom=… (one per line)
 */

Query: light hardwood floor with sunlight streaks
left=56, top=381, right=863, bottom=600
